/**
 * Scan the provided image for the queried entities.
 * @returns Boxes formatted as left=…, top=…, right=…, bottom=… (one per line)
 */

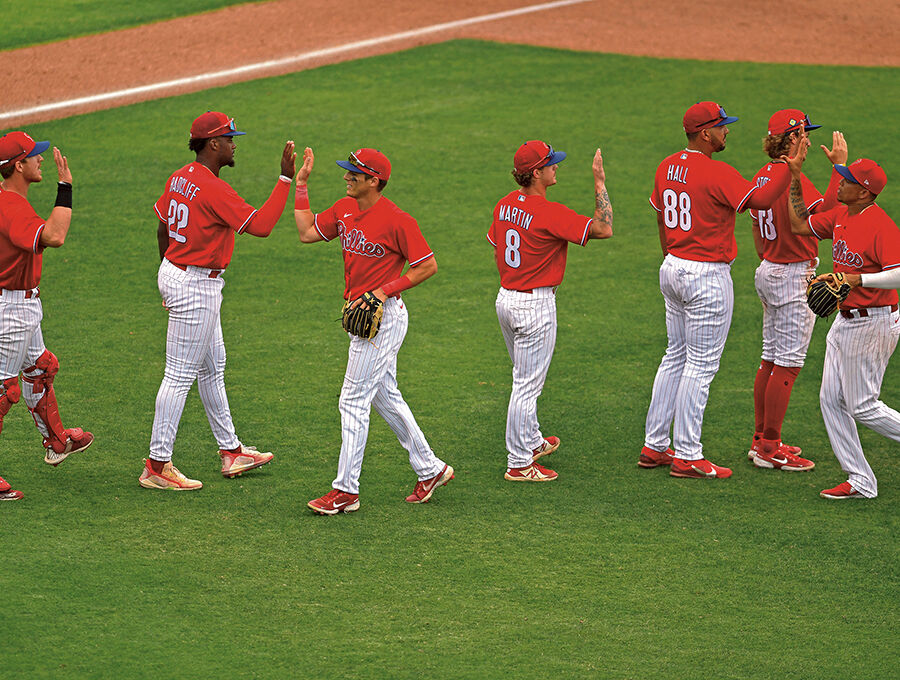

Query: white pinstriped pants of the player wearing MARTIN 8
left=496, top=287, right=556, bottom=468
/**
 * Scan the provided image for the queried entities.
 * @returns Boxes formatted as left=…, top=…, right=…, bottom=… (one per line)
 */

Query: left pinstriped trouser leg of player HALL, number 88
left=644, top=259, right=687, bottom=452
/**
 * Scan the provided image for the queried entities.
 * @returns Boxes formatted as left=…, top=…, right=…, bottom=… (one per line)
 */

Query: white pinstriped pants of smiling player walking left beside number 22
left=332, top=298, right=444, bottom=494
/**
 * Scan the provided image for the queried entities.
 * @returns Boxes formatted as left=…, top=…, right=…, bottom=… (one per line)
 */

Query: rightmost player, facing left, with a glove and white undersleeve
left=789, top=150, right=900, bottom=500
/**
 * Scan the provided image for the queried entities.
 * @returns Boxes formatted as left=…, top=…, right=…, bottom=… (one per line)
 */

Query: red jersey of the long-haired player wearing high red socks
left=750, top=163, right=823, bottom=264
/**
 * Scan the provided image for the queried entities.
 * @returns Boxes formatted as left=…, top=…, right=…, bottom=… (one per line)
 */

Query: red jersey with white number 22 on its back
left=153, top=162, right=256, bottom=269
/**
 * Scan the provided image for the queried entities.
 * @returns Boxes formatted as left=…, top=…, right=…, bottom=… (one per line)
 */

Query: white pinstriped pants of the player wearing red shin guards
left=0, top=290, right=56, bottom=437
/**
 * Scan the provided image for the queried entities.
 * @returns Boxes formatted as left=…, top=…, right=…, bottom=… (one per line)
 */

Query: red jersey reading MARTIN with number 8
left=487, top=190, right=591, bottom=290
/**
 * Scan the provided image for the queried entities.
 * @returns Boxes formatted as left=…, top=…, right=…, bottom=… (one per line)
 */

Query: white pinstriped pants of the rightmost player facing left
left=819, top=307, right=900, bottom=498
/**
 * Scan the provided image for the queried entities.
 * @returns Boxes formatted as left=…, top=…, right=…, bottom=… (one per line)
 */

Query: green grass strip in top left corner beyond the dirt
left=0, top=0, right=254, bottom=50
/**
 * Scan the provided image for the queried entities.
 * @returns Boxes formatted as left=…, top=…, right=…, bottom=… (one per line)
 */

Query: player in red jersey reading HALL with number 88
left=638, top=101, right=790, bottom=478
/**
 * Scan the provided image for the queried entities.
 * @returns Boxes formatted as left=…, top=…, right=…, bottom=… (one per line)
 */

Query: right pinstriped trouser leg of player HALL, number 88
left=672, top=263, right=734, bottom=460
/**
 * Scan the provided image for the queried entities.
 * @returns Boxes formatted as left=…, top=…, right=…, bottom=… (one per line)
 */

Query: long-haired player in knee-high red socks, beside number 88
left=747, top=109, right=847, bottom=472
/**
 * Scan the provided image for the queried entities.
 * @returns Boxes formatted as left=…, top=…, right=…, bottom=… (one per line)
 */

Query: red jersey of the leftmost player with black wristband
left=0, top=190, right=44, bottom=290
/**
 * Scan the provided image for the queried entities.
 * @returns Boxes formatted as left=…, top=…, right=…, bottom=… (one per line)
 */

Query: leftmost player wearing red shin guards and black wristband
left=0, top=131, right=94, bottom=501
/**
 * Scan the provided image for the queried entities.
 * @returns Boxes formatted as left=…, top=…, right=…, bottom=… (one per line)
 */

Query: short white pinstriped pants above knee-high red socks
left=755, top=260, right=816, bottom=368
